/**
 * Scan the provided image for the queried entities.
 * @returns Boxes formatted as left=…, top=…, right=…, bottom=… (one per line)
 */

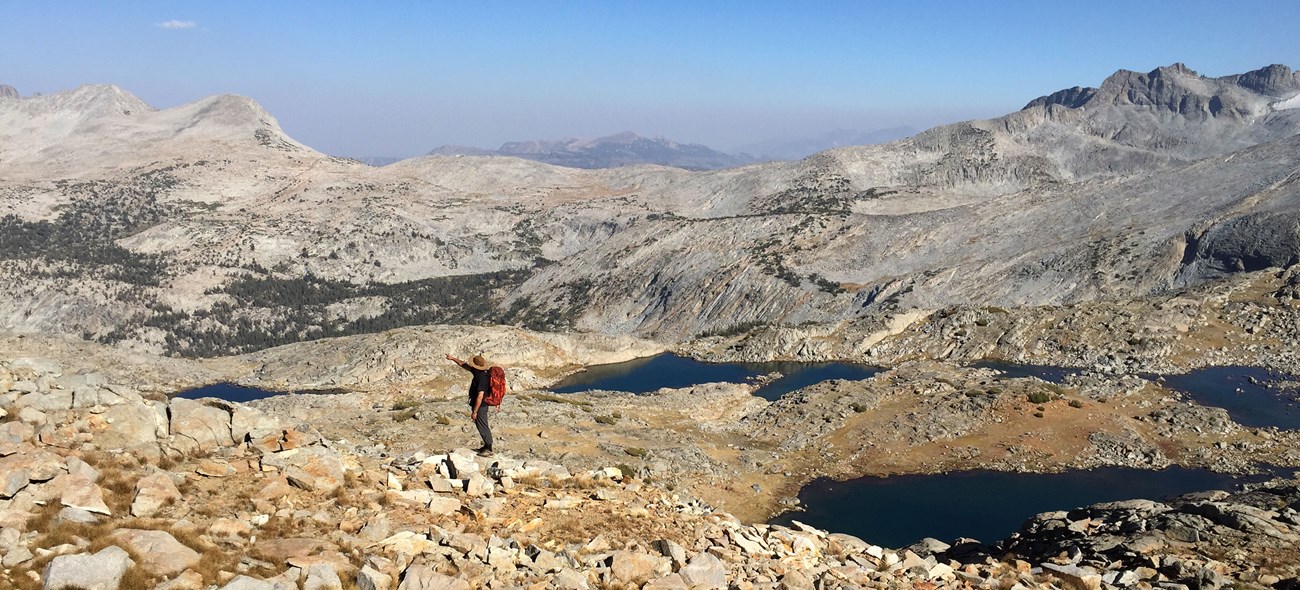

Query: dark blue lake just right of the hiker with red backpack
left=551, top=353, right=880, bottom=400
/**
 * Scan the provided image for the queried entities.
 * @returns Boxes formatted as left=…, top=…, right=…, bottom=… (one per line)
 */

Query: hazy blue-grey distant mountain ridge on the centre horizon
left=429, top=131, right=755, bottom=170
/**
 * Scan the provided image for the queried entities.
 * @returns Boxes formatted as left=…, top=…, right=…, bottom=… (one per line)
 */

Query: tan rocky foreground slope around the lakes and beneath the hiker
left=0, top=283, right=1300, bottom=590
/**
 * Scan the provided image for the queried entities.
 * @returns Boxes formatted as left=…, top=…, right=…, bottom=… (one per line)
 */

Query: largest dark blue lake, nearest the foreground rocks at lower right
left=772, top=468, right=1269, bottom=548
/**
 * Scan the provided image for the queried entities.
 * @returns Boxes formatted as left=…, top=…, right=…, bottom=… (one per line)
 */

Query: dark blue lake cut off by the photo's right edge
left=1165, top=366, right=1300, bottom=430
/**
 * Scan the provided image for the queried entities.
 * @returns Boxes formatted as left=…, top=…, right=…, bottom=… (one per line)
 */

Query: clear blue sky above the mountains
left=0, top=0, right=1300, bottom=156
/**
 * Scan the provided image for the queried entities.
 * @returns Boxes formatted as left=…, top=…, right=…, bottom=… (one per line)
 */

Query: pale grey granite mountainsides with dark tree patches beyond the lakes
left=0, top=66, right=1300, bottom=355
